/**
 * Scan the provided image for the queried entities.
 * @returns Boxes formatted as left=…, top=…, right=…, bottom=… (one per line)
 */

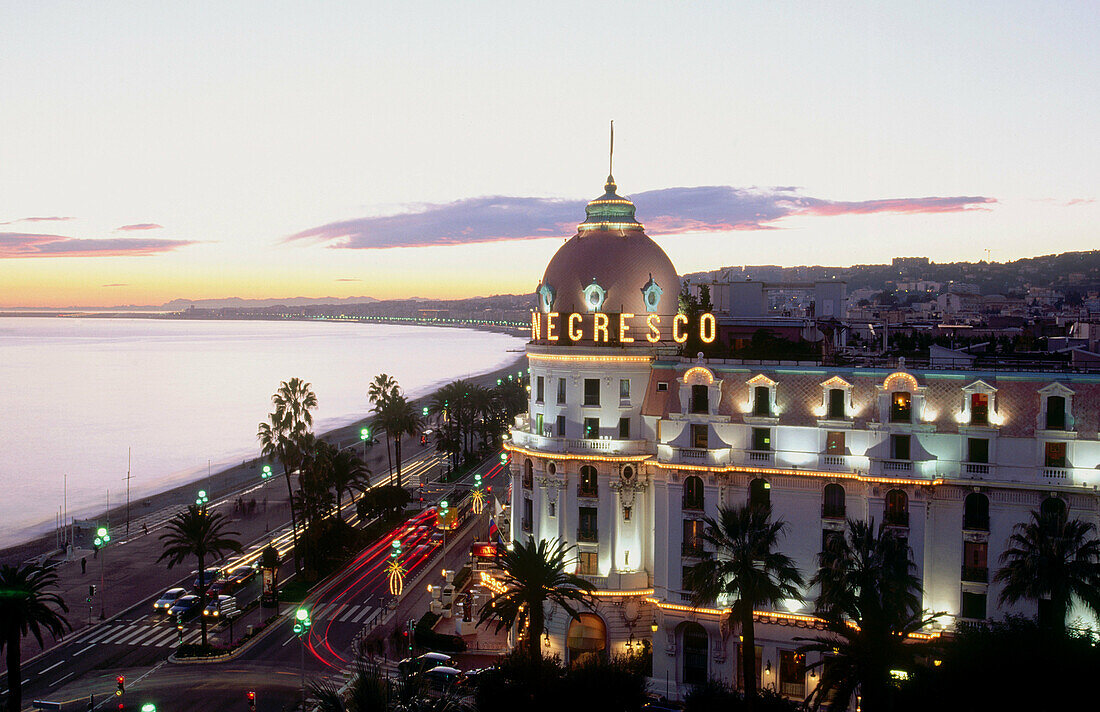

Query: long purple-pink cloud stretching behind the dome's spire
left=287, top=186, right=997, bottom=250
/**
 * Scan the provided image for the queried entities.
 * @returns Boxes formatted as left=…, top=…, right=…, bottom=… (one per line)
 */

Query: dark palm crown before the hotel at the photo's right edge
left=993, top=512, right=1100, bottom=635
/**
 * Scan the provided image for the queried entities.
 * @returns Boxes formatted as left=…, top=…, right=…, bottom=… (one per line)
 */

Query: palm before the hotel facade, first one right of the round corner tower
left=685, top=505, right=803, bottom=708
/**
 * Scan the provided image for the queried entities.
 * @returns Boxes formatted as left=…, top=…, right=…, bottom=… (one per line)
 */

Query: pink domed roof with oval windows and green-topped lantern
left=536, top=175, right=680, bottom=315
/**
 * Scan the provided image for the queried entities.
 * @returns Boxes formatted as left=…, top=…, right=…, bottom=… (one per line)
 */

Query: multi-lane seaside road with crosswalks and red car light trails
left=3, top=454, right=503, bottom=712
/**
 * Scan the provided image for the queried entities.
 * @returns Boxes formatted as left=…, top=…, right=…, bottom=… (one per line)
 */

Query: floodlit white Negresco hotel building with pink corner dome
left=506, top=168, right=1100, bottom=698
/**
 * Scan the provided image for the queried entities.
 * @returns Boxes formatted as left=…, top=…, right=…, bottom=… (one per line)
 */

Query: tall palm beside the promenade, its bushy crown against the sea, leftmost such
left=256, top=379, right=317, bottom=571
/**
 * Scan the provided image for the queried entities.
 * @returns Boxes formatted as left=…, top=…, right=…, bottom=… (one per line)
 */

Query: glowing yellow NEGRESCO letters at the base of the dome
left=531, top=311, right=718, bottom=343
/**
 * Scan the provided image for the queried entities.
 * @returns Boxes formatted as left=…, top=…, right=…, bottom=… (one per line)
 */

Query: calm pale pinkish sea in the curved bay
left=0, top=317, right=525, bottom=546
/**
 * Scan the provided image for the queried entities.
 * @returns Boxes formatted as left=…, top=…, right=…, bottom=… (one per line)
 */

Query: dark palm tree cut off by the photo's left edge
left=0, top=563, right=73, bottom=712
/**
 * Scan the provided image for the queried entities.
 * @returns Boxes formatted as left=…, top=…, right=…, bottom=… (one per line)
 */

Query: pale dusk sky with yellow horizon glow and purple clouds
left=0, top=0, right=1100, bottom=307
